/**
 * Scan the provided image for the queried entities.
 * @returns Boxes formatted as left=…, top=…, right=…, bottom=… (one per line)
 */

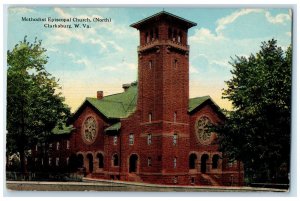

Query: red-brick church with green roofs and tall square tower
left=33, top=11, right=244, bottom=186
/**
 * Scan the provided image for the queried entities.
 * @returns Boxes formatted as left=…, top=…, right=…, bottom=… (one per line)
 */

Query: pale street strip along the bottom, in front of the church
left=6, top=178, right=288, bottom=192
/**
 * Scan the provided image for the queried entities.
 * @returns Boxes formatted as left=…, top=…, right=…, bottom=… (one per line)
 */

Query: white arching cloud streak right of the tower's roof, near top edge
left=216, top=9, right=263, bottom=34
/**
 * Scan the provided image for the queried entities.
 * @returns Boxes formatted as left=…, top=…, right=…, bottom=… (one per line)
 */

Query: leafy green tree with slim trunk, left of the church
left=7, top=36, right=70, bottom=174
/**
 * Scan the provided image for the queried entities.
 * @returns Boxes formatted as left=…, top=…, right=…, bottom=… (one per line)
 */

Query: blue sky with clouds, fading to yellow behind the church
left=7, top=6, right=292, bottom=111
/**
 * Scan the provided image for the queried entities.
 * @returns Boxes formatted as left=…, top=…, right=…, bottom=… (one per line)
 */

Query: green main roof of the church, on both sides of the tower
left=73, top=83, right=218, bottom=119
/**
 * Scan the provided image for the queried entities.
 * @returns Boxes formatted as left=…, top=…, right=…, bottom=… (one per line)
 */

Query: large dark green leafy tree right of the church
left=216, top=39, right=292, bottom=183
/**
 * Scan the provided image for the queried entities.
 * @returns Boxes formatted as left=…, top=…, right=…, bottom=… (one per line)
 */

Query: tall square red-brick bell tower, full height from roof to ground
left=131, top=11, right=196, bottom=181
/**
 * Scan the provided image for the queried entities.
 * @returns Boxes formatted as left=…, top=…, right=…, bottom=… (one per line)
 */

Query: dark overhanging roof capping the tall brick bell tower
left=130, top=10, right=197, bottom=29
